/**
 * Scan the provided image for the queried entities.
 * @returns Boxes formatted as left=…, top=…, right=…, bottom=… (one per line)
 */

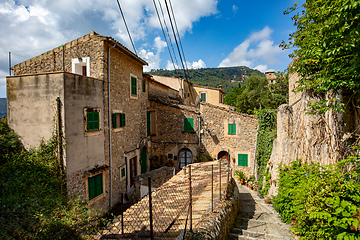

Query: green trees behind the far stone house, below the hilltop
left=224, top=72, right=289, bottom=114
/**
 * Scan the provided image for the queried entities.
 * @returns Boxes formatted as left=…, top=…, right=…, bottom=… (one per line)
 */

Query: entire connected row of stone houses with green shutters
left=7, top=31, right=257, bottom=210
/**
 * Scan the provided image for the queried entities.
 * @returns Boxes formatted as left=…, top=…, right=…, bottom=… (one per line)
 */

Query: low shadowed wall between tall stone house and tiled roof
left=133, top=167, right=175, bottom=202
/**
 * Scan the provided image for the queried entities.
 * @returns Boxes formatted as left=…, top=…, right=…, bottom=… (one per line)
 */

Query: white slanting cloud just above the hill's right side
left=219, top=26, right=282, bottom=72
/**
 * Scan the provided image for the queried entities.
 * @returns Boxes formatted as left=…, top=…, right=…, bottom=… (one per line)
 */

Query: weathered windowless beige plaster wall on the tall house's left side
left=6, top=74, right=64, bottom=149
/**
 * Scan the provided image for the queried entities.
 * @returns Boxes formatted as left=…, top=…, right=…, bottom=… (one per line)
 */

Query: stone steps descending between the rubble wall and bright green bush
left=228, top=184, right=295, bottom=240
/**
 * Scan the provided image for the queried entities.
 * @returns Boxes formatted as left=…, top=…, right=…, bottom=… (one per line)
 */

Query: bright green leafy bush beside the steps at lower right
left=275, top=157, right=360, bottom=239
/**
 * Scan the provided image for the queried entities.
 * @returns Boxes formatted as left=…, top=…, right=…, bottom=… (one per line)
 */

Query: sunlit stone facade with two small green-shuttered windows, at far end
left=200, top=103, right=258, bottom=177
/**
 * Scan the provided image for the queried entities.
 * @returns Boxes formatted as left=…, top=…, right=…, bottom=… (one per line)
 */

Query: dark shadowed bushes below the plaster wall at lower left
left=0, top=126, right=95, bottom=239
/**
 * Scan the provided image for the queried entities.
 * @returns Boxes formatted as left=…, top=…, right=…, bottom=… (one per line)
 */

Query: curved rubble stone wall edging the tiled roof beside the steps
left=187, top=178, right=241, bottom=239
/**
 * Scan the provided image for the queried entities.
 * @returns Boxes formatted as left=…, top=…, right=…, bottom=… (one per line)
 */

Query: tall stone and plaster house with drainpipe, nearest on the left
left=7, top=32, right=149, bottom=210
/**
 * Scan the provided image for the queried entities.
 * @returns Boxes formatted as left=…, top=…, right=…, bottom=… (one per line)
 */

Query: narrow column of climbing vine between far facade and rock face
left=256, top=109, right=276, bottom=195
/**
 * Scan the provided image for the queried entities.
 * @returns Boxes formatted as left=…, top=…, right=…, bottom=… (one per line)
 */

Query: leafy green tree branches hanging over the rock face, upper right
left=280, top=0, right=360, bottom=112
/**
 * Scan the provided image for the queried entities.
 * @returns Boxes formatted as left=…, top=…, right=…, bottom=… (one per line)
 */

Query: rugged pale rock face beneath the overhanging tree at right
left=269, top=70, right=360, bottom=195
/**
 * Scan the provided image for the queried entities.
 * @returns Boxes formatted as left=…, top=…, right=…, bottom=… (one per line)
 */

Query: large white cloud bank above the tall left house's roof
left=0, top=0, right=218, bottom=97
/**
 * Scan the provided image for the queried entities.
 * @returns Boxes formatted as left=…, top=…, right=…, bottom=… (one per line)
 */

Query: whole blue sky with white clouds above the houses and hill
left=0, top=0, right=302, bottom=98
